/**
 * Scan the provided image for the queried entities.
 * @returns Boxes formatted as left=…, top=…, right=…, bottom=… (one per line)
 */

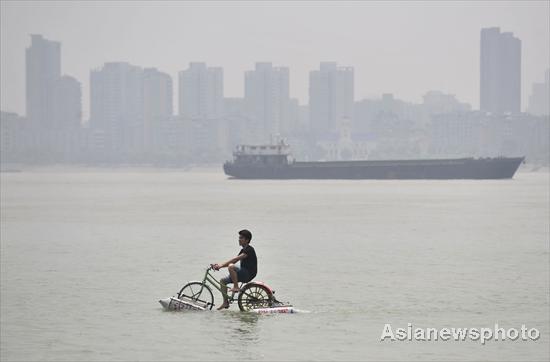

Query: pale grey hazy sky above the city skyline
left=1, top=0, right=550, bottom=119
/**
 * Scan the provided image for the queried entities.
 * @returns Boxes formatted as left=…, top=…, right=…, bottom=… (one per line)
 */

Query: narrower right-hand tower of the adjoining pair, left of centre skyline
left=143, top=68, right=173, bottom=147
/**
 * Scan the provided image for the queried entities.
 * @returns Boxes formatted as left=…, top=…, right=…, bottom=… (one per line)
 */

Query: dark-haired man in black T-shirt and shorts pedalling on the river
left=212, top=229, right=258, bottom=310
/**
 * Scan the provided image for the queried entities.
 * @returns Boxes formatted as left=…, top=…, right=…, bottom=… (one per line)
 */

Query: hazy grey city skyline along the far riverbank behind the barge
left=0, top=3, right=550, bottom=166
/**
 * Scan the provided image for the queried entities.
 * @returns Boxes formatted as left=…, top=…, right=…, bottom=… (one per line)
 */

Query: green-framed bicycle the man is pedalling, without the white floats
left=178, top=265, right=276, bottom=311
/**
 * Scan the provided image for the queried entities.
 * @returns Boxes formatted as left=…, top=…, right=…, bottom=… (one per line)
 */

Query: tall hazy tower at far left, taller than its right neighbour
left=25, top=34, right=61, bottom=129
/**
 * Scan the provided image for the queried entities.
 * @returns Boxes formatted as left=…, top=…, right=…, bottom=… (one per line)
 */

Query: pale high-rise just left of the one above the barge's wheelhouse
left=178, top=62, right=223, bottom=119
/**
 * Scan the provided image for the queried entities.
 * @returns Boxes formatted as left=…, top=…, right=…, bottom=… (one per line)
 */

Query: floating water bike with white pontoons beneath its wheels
left=159, top=265, right=298, bottom=314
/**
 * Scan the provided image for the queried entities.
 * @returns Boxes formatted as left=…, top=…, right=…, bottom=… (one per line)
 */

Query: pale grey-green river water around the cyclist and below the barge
left=0, top=169, right=550, bottom=361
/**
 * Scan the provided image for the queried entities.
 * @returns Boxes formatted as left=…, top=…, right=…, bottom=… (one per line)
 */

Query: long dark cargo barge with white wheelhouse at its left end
left=223, top=143, right=524, bottom=180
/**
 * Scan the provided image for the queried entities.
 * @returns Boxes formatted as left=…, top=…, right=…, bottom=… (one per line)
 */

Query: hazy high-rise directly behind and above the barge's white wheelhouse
left=244, top=62, right=290, bottom=142
